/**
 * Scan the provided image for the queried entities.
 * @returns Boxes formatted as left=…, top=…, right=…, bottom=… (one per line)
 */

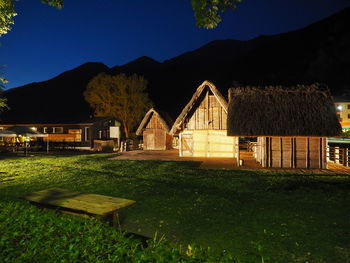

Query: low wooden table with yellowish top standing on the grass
left=21, top=188, right=136, bottom=226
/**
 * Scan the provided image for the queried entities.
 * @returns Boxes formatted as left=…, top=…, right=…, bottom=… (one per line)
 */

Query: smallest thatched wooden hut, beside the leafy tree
left=136, top=108, right=173, bottom=150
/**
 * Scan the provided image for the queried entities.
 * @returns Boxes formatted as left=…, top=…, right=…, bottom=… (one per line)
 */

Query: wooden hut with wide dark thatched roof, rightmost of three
left=228, top=84, right=341, bottom=169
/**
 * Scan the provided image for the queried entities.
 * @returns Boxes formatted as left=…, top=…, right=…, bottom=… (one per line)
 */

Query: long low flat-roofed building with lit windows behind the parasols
left=0, top=117, right=120, bottom=149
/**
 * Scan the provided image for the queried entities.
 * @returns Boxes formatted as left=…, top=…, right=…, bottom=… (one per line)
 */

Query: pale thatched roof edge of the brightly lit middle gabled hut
left=170, top=80, right=228, bottom=134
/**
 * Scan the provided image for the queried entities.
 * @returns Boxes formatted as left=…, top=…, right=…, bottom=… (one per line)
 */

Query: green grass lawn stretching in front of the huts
left=0, top=154, right=350, bottom=263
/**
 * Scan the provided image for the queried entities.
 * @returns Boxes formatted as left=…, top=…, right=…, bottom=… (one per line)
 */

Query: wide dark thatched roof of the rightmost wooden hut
left=227, top=83, right=341, bottom=137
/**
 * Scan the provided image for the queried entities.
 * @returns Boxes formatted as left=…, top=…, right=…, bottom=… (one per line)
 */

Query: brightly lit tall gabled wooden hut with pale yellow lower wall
left=170, top=81, right=237, bottom=157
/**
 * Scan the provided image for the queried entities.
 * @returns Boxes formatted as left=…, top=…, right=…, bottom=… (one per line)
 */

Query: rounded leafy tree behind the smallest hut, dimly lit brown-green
left=84, top=73, right=152, bottom=138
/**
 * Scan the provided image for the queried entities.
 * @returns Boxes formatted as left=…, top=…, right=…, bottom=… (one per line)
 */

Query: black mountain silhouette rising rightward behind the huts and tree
left=0, top=8, right=350, bottom=123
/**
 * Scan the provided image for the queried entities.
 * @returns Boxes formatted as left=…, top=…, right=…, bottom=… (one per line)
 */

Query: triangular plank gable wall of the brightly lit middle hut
left=186, top=93, right=227, bottom=130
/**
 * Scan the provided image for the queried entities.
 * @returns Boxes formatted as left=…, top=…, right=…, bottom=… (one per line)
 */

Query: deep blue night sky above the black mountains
left=0, top=0, right=350, bottom=88
